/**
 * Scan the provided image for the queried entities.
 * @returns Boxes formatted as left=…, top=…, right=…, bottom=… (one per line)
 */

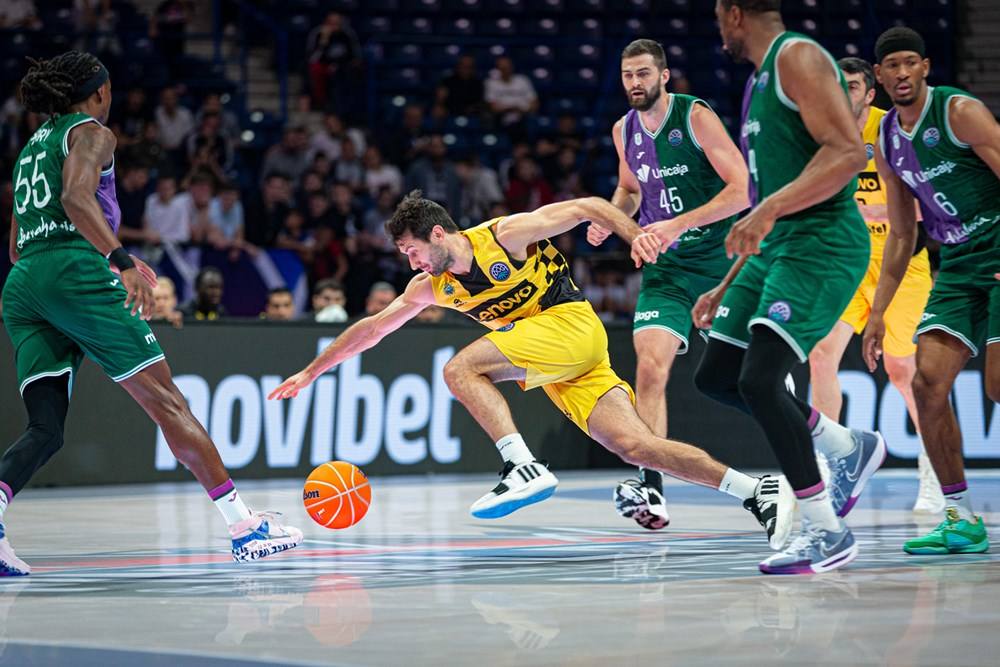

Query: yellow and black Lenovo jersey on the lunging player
left=431, top=218, right=584, bottom=329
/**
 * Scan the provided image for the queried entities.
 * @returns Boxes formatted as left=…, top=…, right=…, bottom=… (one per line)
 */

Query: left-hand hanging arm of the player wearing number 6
left=861, top=144, right=917, bottom=371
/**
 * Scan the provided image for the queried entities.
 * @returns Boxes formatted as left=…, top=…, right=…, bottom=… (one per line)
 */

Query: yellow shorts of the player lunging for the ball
left=486, top=301, right=635, bottom=435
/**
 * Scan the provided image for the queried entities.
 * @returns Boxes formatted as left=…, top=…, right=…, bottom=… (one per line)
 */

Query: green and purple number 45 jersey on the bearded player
left=621, top=93, right=736, bottom=256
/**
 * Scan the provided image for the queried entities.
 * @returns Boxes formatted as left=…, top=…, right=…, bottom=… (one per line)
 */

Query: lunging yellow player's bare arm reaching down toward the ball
left=267, top=273, right=434, bottom=400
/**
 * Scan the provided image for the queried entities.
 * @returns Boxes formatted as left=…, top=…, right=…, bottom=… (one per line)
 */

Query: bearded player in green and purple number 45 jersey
left=587, top=39, right=748, bottom=529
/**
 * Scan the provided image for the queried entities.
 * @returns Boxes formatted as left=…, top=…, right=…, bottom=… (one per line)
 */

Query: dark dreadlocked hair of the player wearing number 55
left=21, top=51, right=104, bottom=115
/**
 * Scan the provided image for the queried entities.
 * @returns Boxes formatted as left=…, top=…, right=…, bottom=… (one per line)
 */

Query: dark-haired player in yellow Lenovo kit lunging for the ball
left=269, top=191, right=794, bottom=548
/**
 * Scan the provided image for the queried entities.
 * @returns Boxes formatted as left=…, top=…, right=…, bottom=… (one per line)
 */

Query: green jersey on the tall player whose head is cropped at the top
left=740, top=32, right=867, bottom=243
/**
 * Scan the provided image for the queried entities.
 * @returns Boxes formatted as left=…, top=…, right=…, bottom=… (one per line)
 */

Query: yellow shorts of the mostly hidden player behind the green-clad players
left=840, top=249, right=932, bottom=357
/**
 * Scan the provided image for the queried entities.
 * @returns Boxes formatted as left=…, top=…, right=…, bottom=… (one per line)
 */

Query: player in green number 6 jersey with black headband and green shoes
left=862, top=27, right=1000, bottom=554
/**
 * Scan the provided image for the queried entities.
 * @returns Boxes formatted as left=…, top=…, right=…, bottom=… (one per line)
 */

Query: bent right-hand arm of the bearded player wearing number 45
left=646, top=104, right=750, bottom=250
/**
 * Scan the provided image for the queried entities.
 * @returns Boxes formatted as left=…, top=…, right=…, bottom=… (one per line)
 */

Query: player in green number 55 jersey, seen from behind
left=0, top=51, right=302, bottom=576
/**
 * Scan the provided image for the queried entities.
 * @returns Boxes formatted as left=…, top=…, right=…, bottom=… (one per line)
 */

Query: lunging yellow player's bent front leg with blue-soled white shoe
left=444, top=336, right=559, bottom=519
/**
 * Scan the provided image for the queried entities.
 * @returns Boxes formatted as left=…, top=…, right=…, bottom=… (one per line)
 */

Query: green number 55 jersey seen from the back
left=14, top=113, right=121, bottom=257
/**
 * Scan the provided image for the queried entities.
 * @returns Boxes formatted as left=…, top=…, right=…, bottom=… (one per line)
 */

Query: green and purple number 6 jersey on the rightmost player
left=879, top=86, right=1000, bottom=244
